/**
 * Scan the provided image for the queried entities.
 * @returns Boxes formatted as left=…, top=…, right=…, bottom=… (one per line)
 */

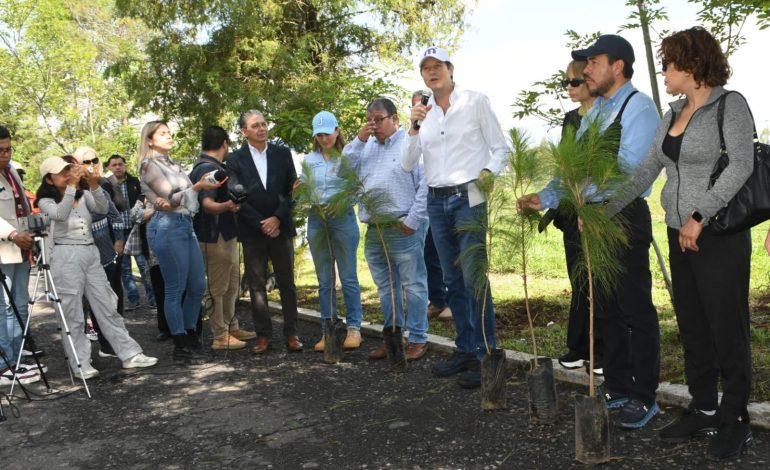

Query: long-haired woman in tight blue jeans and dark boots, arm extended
left=139, top=121, right=221, bottom=363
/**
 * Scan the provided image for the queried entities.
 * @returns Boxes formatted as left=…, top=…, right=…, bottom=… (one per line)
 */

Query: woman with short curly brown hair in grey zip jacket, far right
left=608, top=27, right=754, bottom=459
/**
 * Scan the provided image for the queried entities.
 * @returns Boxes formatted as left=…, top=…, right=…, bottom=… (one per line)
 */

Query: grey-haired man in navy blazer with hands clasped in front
left=227, top=110, right=302, bottom=354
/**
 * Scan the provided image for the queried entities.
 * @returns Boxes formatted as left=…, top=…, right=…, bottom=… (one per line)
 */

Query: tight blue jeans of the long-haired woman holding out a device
left=147, top=211, right=206, bottom=335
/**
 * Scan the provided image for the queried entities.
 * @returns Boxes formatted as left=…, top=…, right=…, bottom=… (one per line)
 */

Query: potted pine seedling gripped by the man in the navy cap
left=508, top=128, right=558, bottom=424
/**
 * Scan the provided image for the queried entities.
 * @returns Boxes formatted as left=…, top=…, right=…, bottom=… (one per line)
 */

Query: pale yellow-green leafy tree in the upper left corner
left=0, top=0, right=142, bottom=184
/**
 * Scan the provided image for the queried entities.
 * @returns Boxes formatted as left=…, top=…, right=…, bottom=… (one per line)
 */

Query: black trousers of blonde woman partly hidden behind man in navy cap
left=553, top=208, right=604, bottom=365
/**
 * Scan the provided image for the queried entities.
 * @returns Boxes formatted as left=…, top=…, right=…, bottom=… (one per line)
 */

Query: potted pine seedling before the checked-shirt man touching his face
left=358, top=185, right=407, bottom=372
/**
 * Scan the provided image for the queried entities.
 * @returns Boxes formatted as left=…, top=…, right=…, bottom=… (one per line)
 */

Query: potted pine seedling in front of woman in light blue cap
left=294, top=156, right=359, bottom=364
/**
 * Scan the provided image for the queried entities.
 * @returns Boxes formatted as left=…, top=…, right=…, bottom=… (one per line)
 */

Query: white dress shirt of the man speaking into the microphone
left=401, top=86, right=510, bottom=188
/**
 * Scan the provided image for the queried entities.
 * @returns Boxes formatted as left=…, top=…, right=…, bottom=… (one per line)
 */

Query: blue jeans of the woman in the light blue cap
left=307, top=207, right=363, bottom=330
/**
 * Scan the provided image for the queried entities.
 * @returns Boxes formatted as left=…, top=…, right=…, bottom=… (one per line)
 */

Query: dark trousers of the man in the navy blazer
left=242, top=237, right=297, bottom=338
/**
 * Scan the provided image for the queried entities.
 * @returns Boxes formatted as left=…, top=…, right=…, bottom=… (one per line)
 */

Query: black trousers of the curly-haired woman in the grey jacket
left=668, top=227, right=751, bottom=423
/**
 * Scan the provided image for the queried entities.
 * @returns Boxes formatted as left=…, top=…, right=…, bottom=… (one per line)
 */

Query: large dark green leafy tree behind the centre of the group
left=110, top=0, right=467, bottom=151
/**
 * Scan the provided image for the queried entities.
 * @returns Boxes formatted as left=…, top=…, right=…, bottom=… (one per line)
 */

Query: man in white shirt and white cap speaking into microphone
left=401, top=47, right=510, bottom=388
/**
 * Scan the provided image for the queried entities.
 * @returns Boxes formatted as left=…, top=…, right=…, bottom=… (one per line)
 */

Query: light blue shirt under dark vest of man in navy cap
left=538, top=80, right=660, bottom=209
